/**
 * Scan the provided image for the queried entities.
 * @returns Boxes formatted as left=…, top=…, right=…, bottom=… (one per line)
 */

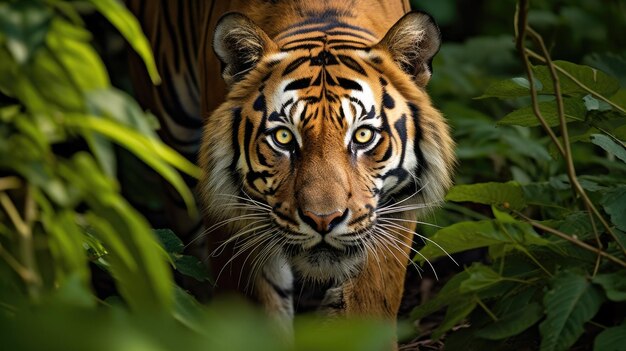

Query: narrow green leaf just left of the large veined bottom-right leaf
left=476, top=302, right=543, bottom=340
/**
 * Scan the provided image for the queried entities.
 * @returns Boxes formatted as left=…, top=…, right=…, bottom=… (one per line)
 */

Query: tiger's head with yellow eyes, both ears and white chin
left=200, top=12, right=454, bottom=281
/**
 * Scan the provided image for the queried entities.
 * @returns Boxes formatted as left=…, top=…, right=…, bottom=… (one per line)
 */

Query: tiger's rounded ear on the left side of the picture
left=213, top=12, right=276, bottom=87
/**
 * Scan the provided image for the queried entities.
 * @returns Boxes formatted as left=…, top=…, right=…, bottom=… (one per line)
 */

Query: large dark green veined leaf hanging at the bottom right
left=539, top=271, right=604, bottom=351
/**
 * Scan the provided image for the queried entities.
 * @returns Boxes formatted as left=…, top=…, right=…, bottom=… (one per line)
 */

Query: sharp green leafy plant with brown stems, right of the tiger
left=412, top=0, right=626, bottom=350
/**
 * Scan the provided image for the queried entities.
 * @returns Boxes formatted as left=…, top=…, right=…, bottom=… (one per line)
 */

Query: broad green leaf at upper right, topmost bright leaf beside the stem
left=534, top=61, right=619, bottom=97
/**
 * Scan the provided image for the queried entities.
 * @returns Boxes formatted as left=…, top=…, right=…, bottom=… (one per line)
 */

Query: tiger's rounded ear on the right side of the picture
left=377, top=11, right=441, bottom=87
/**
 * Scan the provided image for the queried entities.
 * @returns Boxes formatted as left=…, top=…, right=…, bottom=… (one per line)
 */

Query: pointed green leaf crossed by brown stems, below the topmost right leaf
left=498, top=98, right=587, bottom=127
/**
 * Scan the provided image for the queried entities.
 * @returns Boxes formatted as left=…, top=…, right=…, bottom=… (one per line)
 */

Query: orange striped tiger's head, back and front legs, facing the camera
left=198, top=1, right=455, bottom=346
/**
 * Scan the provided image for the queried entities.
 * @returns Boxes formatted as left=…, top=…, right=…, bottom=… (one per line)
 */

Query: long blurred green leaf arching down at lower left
left=59, top=152, right=173, bottom=311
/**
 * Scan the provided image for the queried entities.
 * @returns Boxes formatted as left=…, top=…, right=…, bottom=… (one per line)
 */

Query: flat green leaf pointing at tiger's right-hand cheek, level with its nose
left=446, top=182, right=526, bottom=210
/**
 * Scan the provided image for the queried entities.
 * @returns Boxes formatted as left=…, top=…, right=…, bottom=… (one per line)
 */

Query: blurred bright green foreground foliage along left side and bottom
left=0, top=0, right=392, bottom=351
